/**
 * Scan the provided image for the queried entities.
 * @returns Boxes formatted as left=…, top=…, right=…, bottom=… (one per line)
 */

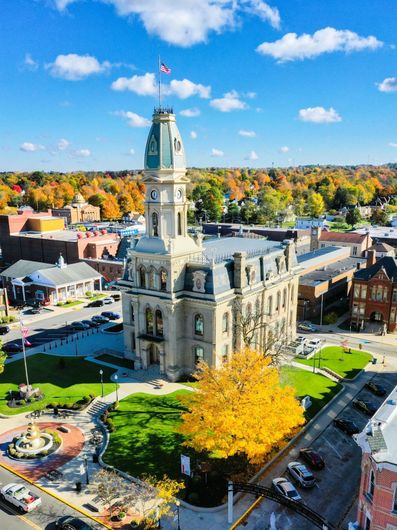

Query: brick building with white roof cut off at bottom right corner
left=356, top=387, right=397, bottom=530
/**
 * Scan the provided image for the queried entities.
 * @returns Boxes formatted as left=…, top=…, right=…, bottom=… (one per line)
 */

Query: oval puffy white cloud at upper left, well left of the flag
left=46, top=53, right=111, bottom=81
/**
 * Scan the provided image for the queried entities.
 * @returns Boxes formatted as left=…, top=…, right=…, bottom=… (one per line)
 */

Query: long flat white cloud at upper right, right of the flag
left=256, top=27, right=383, bottom=63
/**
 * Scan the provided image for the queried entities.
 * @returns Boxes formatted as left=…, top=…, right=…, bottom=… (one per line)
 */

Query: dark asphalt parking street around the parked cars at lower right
left=241, top=373, right=397, bottom=530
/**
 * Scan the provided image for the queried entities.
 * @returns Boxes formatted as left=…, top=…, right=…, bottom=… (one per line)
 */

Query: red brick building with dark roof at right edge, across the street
left=350, top=250, right=397, bottom=332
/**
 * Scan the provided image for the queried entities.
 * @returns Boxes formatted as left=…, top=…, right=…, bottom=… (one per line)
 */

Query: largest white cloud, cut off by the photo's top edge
left=54, top=0, right=280, bottom=47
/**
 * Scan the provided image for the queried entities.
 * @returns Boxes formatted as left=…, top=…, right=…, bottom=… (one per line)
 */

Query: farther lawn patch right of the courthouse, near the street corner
left=295, top=346, right=372, bottom=379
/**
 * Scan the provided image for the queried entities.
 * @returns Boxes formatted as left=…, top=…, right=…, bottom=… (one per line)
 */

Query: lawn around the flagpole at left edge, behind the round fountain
left=0, top=353, right=115, bottom=415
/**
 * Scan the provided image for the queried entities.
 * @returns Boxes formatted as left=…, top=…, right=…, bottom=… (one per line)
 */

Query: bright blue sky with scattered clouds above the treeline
left=0, top=0, right=397, bottom=171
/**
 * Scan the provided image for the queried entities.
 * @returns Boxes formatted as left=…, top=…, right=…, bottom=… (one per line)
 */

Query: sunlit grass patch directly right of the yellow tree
left=281, top=366, right=342, bottom=419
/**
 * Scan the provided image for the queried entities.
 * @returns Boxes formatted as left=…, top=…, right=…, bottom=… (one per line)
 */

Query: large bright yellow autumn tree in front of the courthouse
left=179, top=348, right=304, bottom=463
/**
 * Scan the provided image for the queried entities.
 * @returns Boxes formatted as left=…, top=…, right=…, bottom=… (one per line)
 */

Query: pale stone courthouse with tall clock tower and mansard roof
left=120, top=109, right=299, bottom=381
